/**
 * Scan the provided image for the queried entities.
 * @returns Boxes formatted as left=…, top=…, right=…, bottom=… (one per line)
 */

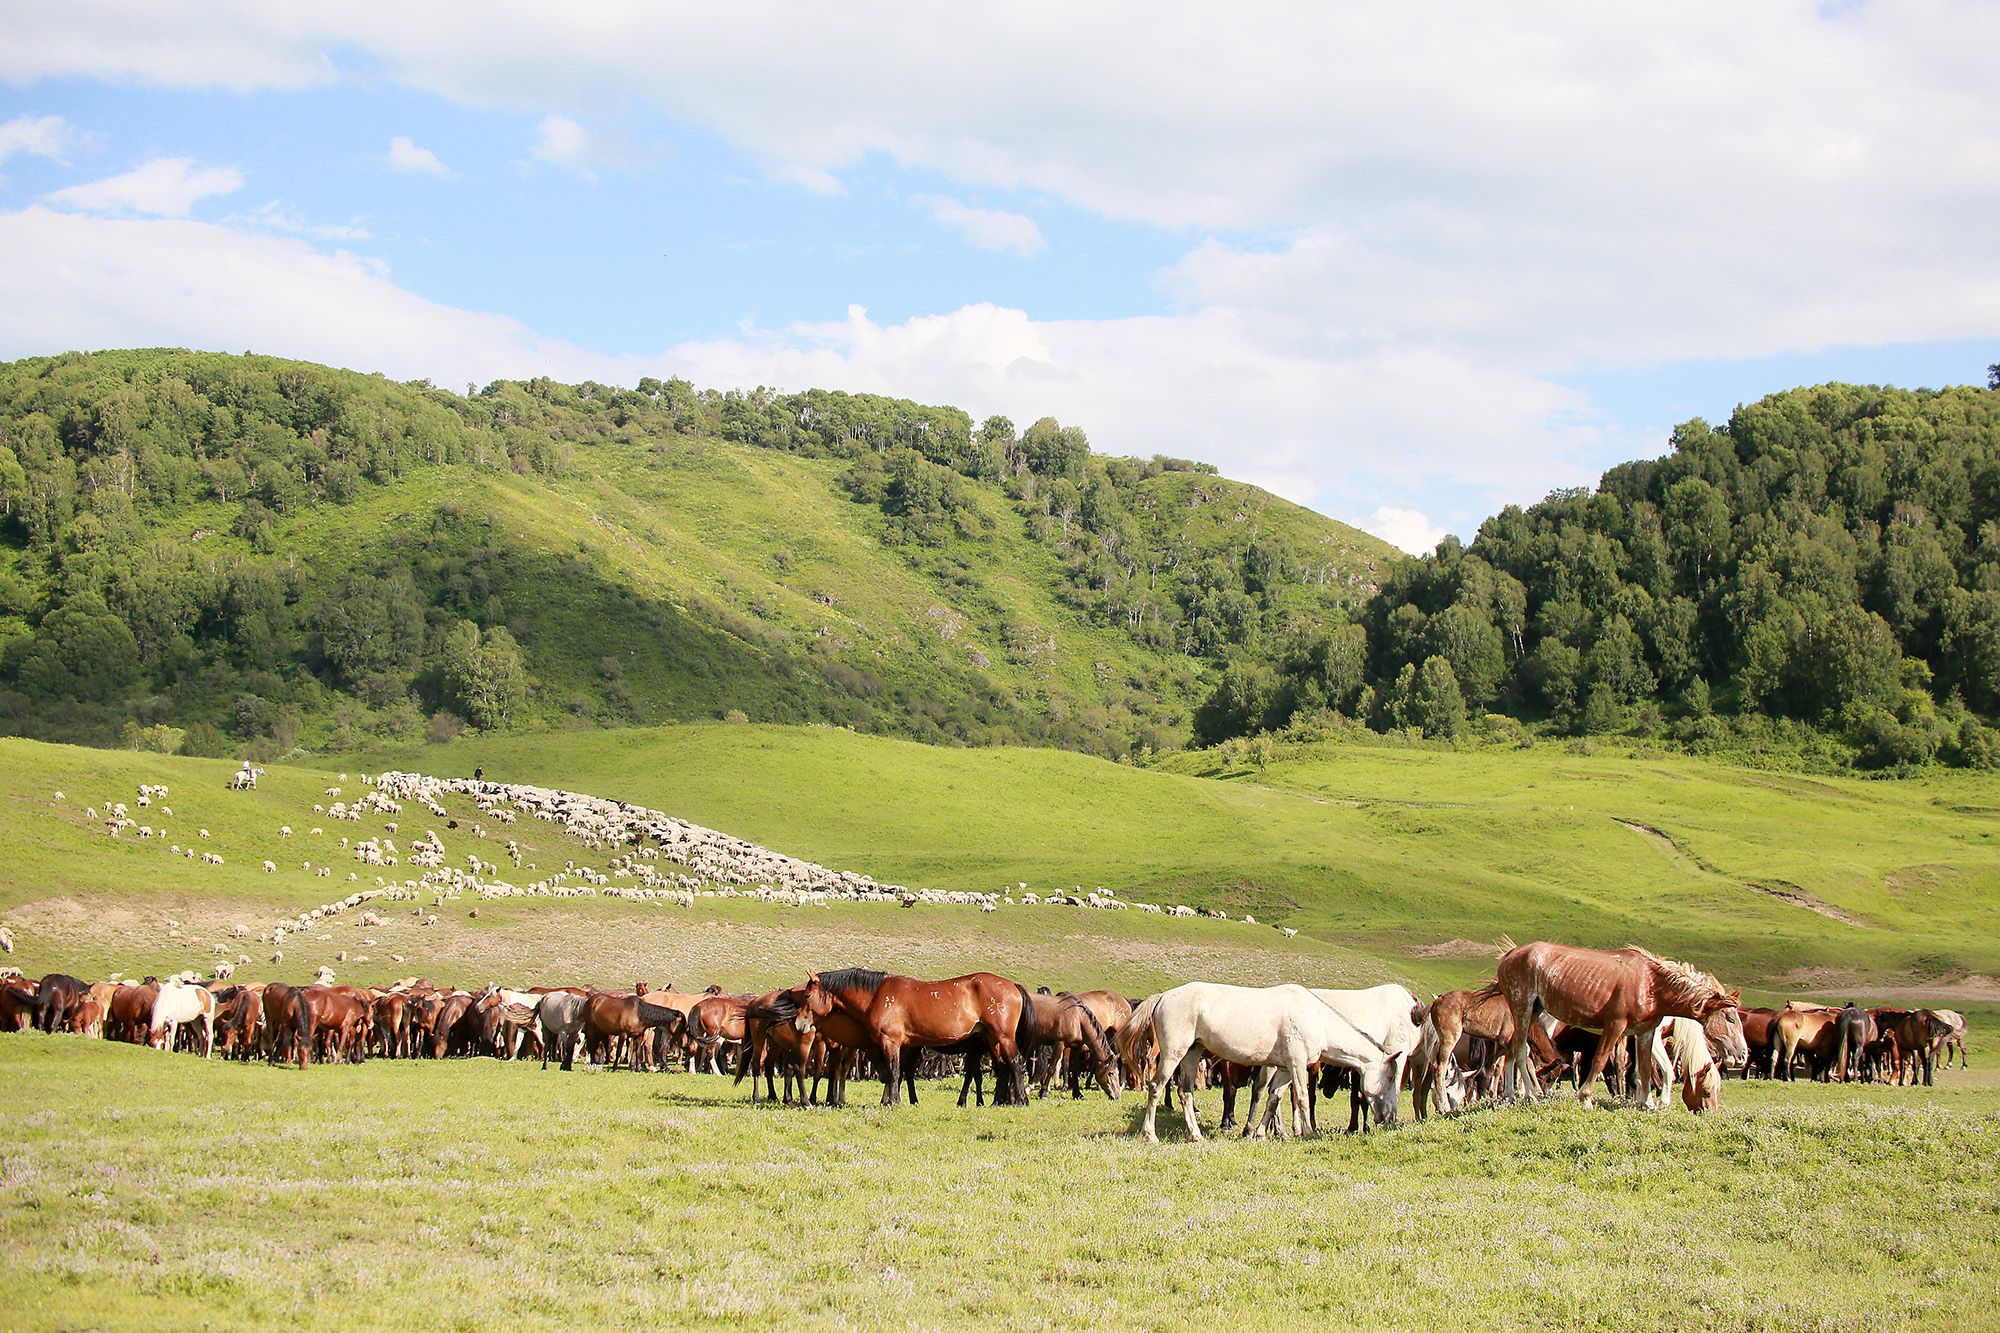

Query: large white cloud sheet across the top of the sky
left=0, top=0, right=2000, bottom=370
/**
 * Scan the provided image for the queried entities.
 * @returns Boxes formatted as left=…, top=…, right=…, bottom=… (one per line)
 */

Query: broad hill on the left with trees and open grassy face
left=0, top=350, right=1402, bottom=755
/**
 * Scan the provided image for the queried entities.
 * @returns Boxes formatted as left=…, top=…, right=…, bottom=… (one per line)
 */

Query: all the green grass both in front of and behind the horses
left=0, top=725, right=2000, bottom=1329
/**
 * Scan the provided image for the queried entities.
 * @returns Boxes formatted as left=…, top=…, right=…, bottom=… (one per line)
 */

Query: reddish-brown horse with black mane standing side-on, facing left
left=804, top=969, right=1034, bottom=1107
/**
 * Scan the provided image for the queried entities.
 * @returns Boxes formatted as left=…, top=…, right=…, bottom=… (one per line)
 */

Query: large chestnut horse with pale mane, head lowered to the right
left=1498, top=941, right=1740, bottom=1107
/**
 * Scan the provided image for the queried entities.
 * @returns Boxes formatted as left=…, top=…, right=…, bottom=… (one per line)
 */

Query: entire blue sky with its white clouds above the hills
left=0, top=0, right=2000, bottom=546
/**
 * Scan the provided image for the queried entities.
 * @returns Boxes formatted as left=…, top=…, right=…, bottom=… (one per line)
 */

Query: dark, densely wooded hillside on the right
left=1198, top=384, right=2000, bottom=767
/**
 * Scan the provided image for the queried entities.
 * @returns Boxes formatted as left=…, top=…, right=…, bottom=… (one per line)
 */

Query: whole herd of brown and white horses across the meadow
left=0, top=943, right=1964, bottom=1139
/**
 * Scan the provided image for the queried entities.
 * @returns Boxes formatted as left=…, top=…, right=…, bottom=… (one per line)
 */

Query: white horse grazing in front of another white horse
left=1140, top=981, right=1396, bottom=1143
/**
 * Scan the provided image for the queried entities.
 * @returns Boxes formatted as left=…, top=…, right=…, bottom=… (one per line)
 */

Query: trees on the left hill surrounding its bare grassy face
left=0, top=350, right=1366, bottom=753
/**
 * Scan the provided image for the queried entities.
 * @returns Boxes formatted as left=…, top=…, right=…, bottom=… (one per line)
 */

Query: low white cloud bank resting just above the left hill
left=0, top=208, right=1604, bottom=524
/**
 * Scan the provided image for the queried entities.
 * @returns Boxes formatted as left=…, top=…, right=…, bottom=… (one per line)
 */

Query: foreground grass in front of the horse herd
left=0, top=1035, right=2000, bottom=1329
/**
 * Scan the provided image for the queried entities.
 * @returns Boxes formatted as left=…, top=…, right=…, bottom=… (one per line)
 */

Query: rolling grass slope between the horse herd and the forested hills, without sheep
left=0, top=725, right=2000, bottom=1007
